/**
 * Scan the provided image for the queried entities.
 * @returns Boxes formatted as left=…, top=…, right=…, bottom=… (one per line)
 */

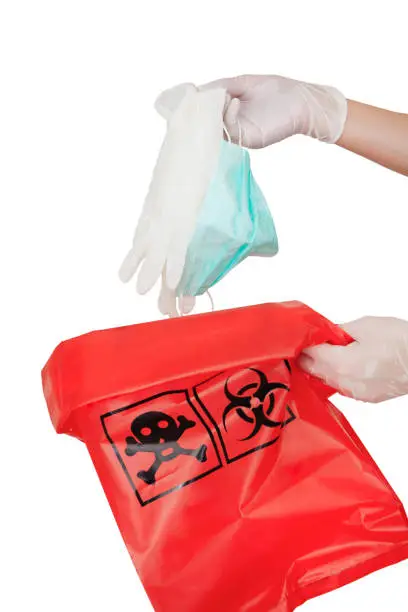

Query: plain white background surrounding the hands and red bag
left=0, top=0, right=408, bottom=612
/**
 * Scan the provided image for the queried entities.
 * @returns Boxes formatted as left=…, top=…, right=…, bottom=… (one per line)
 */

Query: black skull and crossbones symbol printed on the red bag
left=125, top=411, right=207, bottom=484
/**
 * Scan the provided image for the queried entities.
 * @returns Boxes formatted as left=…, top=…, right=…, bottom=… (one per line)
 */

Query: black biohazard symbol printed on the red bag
left=223, top=362, right=295, bottom=440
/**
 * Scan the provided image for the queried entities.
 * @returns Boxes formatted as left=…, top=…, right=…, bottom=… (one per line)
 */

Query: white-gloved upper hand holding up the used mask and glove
left=203, top=75, right=347, bottom=149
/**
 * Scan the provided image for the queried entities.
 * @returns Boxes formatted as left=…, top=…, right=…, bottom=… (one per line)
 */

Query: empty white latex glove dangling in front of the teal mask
left=120, top=85, right=226, bottom=296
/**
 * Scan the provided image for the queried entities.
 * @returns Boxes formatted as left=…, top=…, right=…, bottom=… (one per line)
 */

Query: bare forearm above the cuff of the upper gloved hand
left=337, top=100, right=408, bottom=176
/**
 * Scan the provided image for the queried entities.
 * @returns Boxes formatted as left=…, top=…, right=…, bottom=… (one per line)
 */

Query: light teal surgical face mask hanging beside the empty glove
left=177, top=142, right=278, bottom=296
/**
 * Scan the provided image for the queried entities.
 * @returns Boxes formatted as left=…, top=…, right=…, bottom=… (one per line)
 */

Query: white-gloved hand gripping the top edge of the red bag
left=299, top=317, right=408, bottom=403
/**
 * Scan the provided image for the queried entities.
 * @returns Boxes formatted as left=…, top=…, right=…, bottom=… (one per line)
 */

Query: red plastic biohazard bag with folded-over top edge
left=43, top=303, right=408, bottom=612
